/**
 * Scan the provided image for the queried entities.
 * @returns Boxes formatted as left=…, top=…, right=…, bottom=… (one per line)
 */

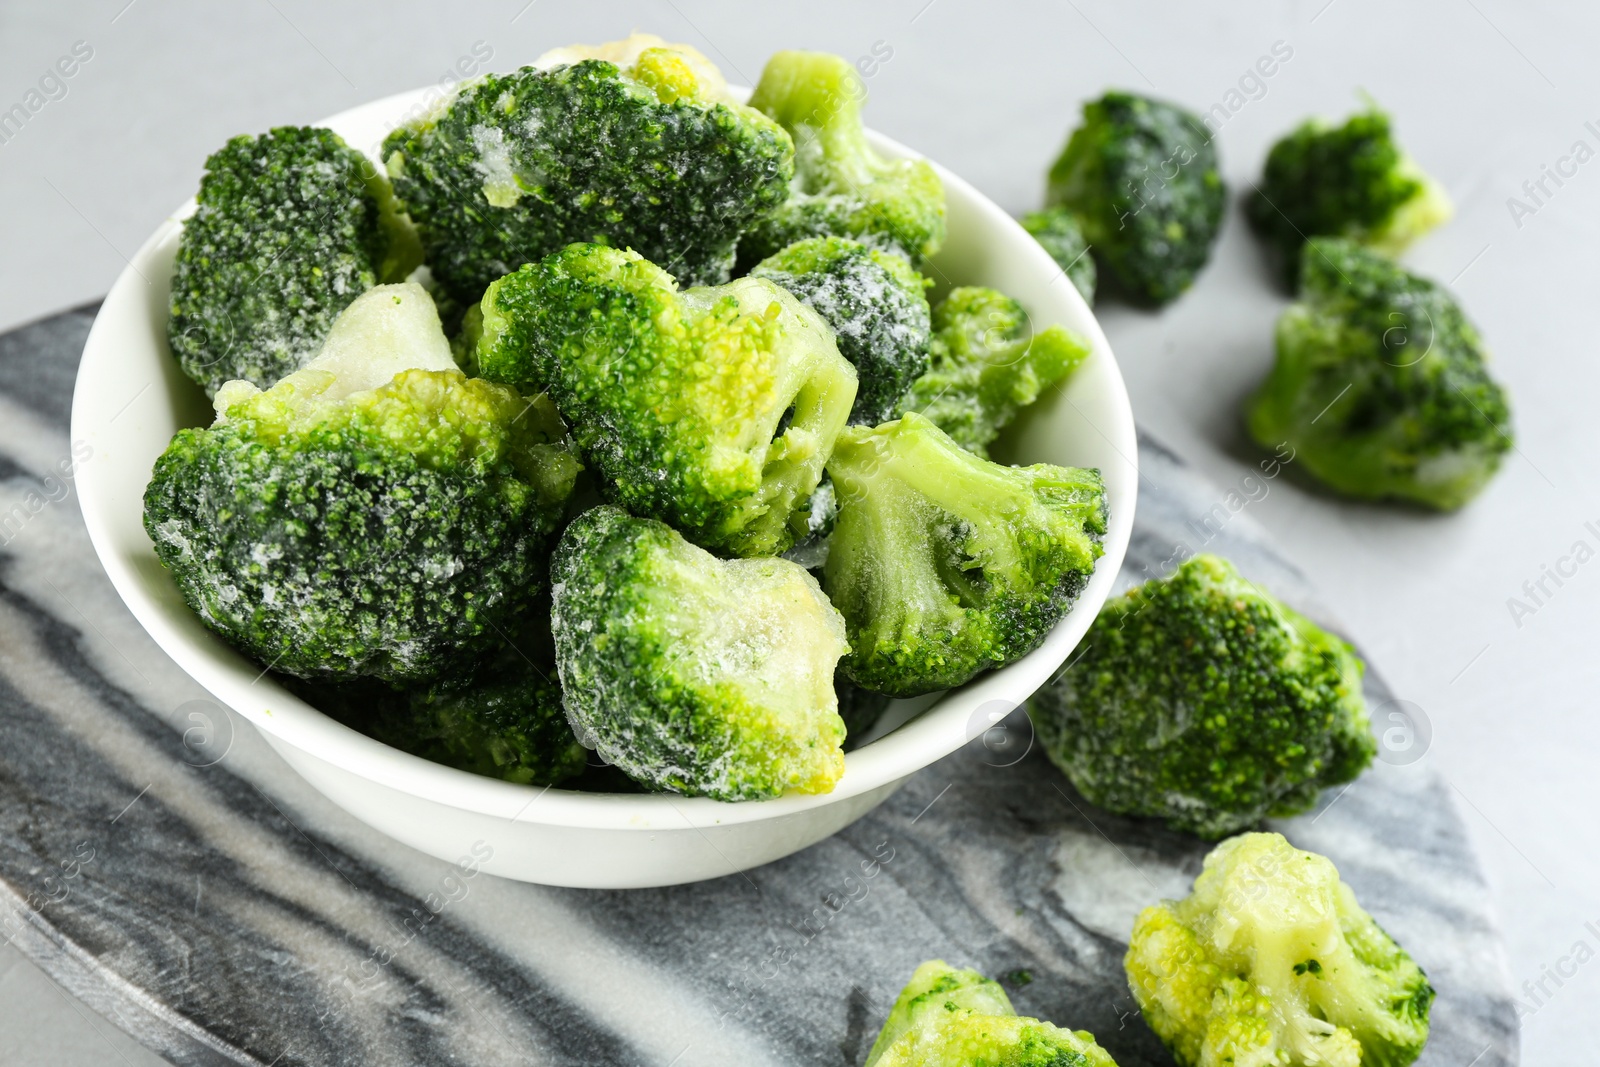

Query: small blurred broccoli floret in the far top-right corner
left=1248, top=107, right=1451, bottom=277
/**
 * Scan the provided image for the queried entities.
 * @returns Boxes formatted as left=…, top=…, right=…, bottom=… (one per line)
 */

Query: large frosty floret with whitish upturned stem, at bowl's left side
left=144, top=283, right=579, bottom=683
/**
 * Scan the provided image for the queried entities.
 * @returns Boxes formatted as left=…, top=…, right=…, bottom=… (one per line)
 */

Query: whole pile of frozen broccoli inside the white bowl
left=146, top=37, right=1106, bottom=800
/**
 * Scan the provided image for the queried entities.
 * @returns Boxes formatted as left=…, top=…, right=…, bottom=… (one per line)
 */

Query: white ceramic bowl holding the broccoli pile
left=72, top=83, right=1138, bottom=888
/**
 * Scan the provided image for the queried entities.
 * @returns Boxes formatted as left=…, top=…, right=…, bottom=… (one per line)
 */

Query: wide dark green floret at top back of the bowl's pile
left=384, top=48, right=794, bottom=304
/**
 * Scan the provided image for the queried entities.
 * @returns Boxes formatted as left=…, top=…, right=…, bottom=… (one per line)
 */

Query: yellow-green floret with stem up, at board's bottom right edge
left=1125, top=833, right=1434, bottom=1067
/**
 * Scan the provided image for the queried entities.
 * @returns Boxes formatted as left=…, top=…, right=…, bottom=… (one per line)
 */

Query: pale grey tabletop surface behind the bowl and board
left=0, top=0, right=1600, bottom=1067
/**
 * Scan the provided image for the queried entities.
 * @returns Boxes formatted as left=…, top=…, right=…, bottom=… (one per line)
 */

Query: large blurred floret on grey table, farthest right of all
left=1245, top=237, right=1512, bottom=510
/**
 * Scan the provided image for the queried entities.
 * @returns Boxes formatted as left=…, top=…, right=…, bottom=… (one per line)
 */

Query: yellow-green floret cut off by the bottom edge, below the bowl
left=866, top=960, right=1117, bottom=1067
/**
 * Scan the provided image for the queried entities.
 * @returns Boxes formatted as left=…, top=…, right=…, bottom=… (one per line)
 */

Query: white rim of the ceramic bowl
left=72, top=86, right=1138, bottom=830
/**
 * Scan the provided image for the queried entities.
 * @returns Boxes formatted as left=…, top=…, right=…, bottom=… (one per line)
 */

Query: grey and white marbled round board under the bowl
left=0, top=309, right=1517, bottom=1067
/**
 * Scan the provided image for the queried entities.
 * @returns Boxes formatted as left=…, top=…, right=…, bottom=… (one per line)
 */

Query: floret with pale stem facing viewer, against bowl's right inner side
left=822, top=413, right=1106, bottom=696
